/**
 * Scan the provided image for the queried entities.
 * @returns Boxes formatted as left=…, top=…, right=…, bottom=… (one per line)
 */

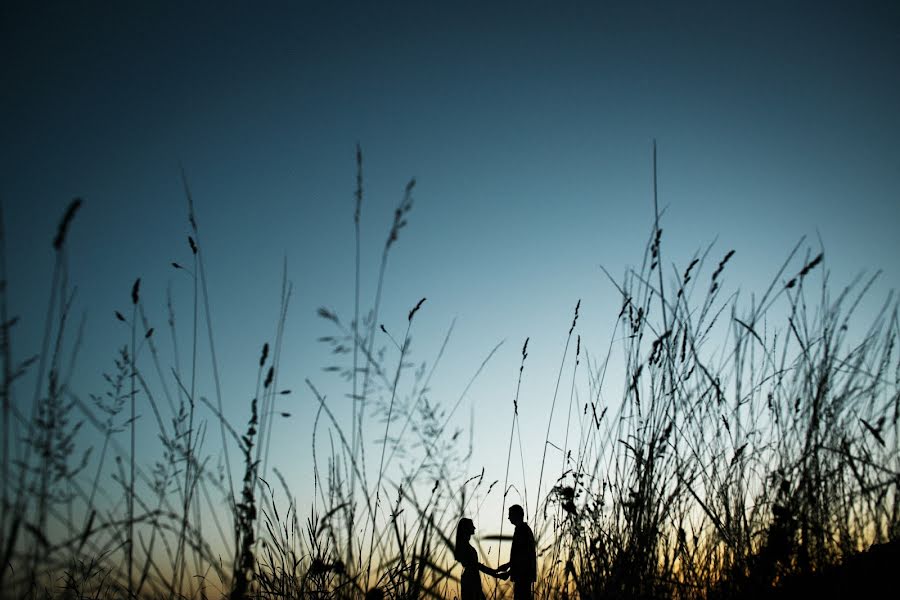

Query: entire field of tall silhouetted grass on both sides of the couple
left=0, top=151, right=900, bottom=599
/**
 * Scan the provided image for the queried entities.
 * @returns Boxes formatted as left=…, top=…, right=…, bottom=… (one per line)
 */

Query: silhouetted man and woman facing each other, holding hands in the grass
left=453, top=504, right=537, bottom=600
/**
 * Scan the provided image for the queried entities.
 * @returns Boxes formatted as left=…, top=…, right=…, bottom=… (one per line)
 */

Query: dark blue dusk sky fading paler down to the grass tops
left=0, top=1, right=900, bottom=564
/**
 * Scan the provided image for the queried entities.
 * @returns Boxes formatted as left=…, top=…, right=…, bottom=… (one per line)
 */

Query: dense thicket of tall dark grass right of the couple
left=540, top=165, right=900, bottom=598
